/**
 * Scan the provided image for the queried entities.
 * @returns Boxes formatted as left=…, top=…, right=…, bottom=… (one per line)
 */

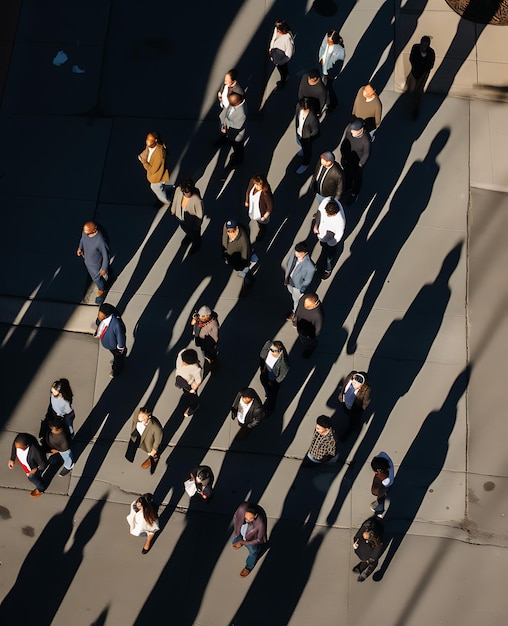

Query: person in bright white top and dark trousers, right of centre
left=313, top=197, right=346, bottom=280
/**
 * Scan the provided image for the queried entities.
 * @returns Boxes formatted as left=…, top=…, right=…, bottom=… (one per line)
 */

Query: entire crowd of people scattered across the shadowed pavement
left=8, top=20, right=435, bottom=581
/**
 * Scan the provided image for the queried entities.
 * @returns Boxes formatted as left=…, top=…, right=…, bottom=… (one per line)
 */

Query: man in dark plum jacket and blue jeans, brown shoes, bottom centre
left=231, top=502, right=268, bottom=578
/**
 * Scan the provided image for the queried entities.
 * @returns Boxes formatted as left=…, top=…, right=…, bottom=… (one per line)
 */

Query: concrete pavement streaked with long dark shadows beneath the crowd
left=0, top=0, right=508, bottom=626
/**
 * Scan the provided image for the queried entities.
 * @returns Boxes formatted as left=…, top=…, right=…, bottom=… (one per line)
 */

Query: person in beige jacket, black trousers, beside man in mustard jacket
left=171, top=178, right=203, bottom=254
